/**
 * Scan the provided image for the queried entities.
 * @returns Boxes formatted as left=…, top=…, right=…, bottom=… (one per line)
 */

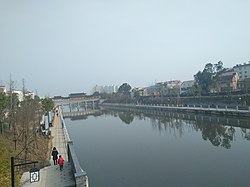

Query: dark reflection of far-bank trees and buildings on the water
left=62, top=108, right=250, bottom=149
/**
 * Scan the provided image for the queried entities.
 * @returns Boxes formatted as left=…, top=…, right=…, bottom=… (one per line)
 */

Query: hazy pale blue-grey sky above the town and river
left=0, top=0, right=250, bottom=97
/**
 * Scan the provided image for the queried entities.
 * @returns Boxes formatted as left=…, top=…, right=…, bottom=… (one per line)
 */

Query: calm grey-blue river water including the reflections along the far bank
left=65, top=106, right=250, bottom=187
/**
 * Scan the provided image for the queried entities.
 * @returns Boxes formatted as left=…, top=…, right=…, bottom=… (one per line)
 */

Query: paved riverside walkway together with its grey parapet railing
left=21, top=108, right=89, bottom=187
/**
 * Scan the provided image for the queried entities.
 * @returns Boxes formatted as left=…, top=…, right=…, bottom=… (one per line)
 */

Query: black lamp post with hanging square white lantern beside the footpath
left=10, top=157, right=39, bottom=187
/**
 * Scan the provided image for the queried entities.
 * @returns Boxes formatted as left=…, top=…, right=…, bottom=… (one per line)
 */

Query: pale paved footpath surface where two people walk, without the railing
left=21, top=113, right=75, bottom=187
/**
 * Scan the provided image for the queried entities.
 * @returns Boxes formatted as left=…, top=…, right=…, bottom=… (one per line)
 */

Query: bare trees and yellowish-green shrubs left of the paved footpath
left=0, top=81, right=54, bottom=186
